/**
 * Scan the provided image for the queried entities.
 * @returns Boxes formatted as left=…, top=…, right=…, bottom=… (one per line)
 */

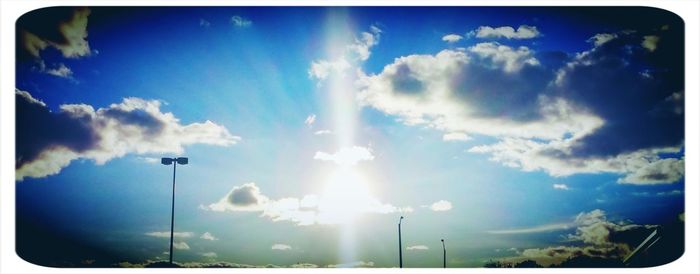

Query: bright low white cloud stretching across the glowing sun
left=205, top=183, right=413, bottom=226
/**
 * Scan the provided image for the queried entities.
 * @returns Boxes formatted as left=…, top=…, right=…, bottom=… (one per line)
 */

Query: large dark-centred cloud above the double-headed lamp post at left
left=15, top=90, right=240, bottom=181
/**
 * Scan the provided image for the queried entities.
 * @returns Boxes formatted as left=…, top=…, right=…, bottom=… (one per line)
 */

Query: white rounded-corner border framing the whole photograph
left=0, top=0, right=700, bottom=273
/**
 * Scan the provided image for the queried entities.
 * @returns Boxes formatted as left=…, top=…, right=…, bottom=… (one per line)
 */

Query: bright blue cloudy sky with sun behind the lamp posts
left=15, top=7, right=685, bottom=267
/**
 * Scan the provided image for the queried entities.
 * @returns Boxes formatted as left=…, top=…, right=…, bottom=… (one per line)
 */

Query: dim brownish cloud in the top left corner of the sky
left=17, top=7, right=91, bottom=59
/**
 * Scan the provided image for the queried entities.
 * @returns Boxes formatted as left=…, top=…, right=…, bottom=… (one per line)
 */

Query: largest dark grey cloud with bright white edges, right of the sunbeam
left=357, top=27, right=684, bottom=184
